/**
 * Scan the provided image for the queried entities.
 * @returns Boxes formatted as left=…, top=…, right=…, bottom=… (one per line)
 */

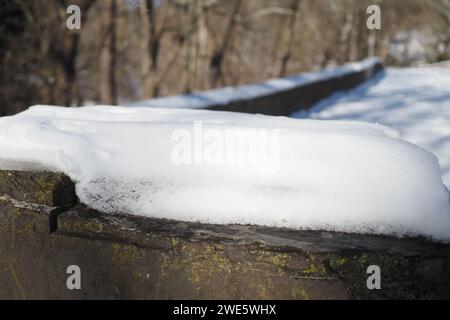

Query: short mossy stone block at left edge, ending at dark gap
left=0, top=171, right=77, bottom=207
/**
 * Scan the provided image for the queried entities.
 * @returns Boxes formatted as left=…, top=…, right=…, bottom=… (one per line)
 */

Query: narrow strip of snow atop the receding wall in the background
left=128, top=58, right=380, bottom=109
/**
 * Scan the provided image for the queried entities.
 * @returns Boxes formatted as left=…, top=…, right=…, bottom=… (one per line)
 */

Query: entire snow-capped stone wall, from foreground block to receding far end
left=0, top=59, right=450, bottom=299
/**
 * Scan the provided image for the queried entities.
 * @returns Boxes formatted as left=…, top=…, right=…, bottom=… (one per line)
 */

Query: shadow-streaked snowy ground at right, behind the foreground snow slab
left=293, top=67, right=450, bottom=188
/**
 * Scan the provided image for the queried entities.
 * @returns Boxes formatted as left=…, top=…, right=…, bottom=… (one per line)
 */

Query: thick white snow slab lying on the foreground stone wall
left=0, top=105, right=450, bottom=241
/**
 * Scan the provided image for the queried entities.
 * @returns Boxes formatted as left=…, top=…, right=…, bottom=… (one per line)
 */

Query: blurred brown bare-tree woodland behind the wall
left=0, top=0, right=450, bottom=116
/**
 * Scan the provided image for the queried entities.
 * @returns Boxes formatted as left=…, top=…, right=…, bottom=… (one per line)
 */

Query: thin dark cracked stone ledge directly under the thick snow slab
left=58, top=205, right=450, bottom=258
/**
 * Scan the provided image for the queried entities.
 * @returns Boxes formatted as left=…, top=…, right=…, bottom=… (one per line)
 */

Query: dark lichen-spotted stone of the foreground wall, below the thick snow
left=0, top=171, right=450, bottom=299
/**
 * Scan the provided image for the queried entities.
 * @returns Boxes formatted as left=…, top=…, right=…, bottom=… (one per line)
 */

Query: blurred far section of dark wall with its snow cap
left=130, top=58, right=383, bottom=116
